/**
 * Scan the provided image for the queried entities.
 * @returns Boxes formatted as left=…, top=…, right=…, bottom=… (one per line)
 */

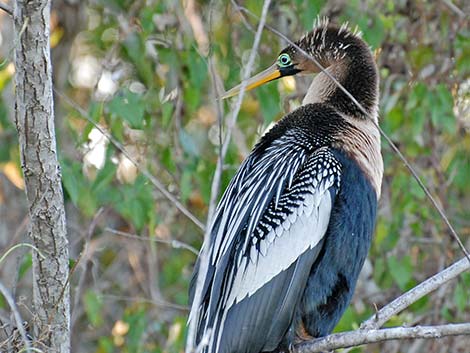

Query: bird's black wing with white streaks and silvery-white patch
left=190, top=131, right=340, bottom=353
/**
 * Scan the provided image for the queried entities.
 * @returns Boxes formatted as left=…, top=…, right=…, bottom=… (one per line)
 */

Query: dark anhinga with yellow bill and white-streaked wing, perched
left=189, top=19, right=383, bottom=353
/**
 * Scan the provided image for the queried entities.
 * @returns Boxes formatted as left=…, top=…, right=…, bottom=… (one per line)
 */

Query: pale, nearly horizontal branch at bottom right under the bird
left=294, top=323, right=470, bottom=353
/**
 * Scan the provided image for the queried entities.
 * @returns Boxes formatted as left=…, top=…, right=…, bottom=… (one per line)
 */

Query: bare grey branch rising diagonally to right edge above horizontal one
left=361, top=257, right=470, bottom=329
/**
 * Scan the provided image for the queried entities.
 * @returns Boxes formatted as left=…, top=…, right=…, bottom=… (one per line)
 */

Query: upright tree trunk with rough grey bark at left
left=14, top=0, right=70, bottom=353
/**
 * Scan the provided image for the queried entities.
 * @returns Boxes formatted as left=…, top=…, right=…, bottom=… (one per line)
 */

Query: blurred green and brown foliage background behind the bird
left=0, top=0, right=470, bottom=353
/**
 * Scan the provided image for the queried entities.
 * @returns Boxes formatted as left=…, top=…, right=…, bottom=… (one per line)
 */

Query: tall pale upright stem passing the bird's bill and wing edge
left=186, top=0, right=271, bottom=353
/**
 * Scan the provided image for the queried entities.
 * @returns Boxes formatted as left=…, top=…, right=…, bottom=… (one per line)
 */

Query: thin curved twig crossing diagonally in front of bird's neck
left=231, top=5, right=470, bottom=262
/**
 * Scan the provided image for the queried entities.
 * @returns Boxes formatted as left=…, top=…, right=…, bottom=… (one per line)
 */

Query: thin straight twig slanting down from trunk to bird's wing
left=54, top=89, right=204, bottom=231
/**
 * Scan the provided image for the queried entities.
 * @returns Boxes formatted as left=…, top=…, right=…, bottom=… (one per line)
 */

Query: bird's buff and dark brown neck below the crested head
left=303, top=57, right=383, bottom=198
